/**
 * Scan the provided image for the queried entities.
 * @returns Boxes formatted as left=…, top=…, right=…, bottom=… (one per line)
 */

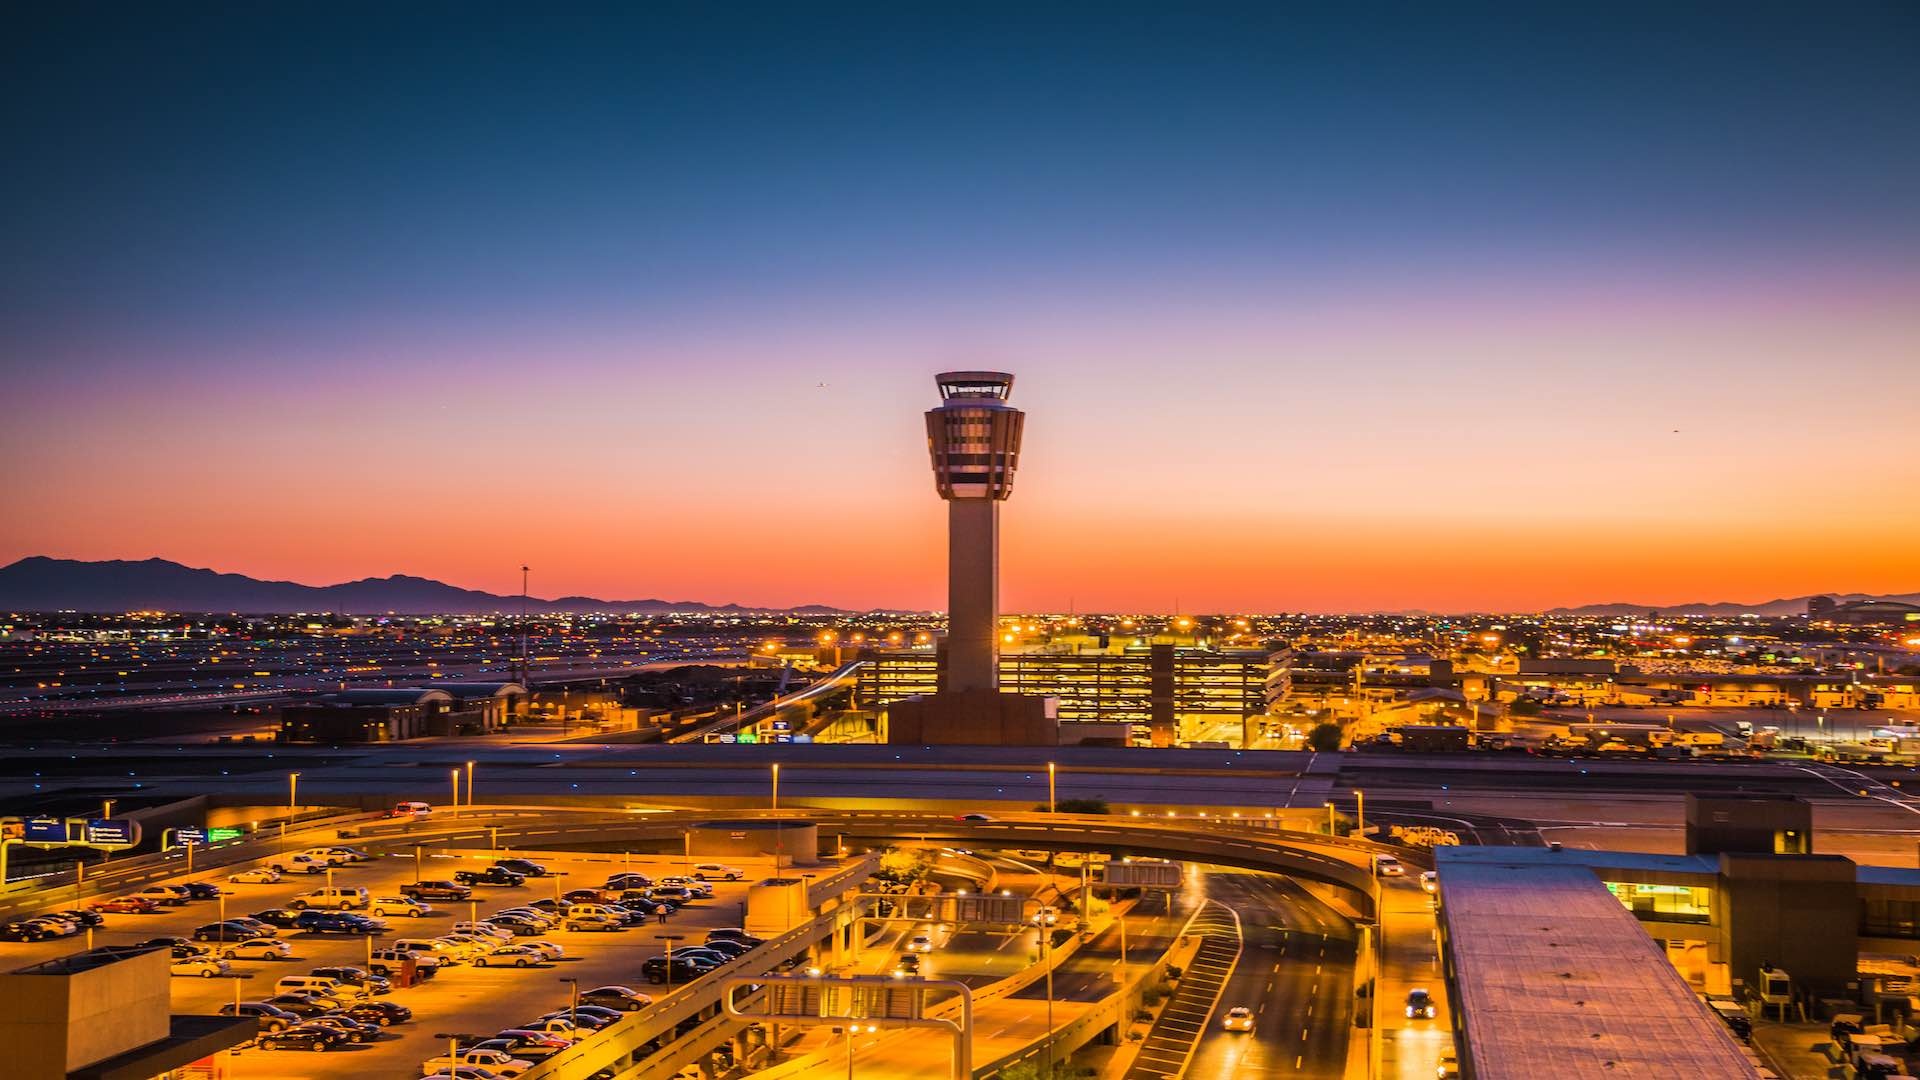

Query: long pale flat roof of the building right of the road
left=1438, top=847, right=1759, bottom=1080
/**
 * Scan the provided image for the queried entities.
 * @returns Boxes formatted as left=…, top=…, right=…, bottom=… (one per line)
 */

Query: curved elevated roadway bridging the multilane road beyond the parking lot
left=355, top=807, right=1386, bottom=915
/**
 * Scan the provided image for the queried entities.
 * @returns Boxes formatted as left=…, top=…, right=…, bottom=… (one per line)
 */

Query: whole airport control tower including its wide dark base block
left=887, top=371, right=1060, bottom=746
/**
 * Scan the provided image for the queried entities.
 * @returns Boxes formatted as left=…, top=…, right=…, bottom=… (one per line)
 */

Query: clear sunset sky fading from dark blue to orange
left=0, top=2, right=1920, bottom=611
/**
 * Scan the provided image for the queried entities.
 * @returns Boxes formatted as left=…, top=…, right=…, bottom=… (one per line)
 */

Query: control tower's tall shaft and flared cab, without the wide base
left=927, top=371, right=1027, bottom=690
